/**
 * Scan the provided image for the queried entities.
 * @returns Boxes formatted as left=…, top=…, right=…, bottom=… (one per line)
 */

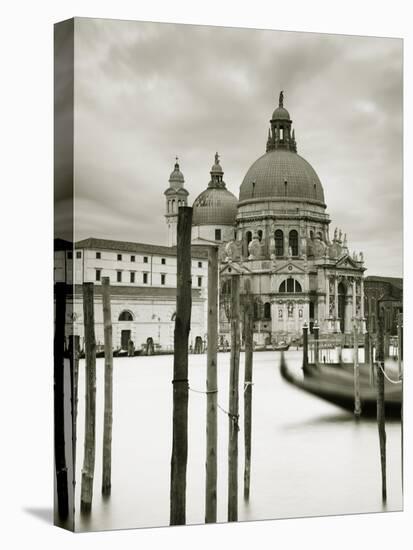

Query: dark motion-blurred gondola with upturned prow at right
left=280, top=354, right=403, bottom=418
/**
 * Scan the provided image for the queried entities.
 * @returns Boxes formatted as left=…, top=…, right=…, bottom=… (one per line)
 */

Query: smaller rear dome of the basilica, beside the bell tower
left=192, top=187, right=238, bottom=225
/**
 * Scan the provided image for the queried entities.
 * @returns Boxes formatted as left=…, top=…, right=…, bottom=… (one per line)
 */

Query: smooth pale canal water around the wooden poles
left=76, top=351, right=402, bottom=531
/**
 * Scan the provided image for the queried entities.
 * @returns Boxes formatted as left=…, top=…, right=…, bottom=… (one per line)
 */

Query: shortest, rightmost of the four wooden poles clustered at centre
left=244, top=292, right=254, bottom=500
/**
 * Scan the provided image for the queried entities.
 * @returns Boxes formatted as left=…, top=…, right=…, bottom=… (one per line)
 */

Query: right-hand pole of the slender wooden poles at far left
left=102, top=277, right=113, bottom=495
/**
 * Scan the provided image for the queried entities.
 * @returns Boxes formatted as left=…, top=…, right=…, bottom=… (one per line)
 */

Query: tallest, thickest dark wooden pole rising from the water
left=170, top=206, right=192, bottom=525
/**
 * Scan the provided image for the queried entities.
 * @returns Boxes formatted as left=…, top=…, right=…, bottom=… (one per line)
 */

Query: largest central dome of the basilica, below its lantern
left=239, top=149, right=324, bottom=206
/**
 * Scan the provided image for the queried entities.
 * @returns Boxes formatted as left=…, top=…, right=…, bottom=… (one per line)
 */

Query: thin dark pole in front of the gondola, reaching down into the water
left=376, top=301, right=387, bottom=502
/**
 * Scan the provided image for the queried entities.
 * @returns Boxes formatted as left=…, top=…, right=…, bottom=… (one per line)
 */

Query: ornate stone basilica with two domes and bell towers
left=165, top=92, right=365, bottom=344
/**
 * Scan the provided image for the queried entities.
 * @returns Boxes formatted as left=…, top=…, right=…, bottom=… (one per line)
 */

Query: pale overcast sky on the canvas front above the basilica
left=66, top=19, right=403, bottom=276
